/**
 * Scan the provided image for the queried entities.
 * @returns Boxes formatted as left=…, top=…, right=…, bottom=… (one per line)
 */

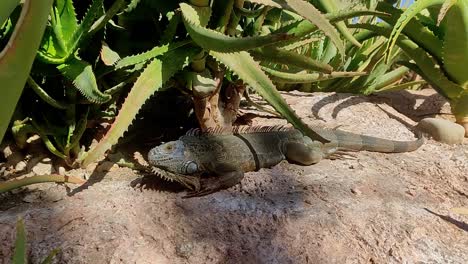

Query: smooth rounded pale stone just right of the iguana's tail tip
left=417, top=118, right=465, bottom=144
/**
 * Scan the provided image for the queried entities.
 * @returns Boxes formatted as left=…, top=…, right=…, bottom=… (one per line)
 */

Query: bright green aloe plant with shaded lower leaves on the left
left=6, top=0, right=132, bottom=165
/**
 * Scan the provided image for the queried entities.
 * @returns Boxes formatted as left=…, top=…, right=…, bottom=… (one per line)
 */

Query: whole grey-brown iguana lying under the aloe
left=148, top=126, right=424, bottom=197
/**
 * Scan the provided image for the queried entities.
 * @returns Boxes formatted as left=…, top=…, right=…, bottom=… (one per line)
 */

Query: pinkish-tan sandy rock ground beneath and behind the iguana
left=0, top=90, right=468, bottom=263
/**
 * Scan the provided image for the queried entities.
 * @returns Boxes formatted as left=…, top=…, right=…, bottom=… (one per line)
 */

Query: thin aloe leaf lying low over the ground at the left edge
left=0, top=174, right=86, bottom=193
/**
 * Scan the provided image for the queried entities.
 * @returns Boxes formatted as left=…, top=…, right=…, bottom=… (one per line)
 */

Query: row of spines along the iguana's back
left=185, top=125, right=293, bottom=136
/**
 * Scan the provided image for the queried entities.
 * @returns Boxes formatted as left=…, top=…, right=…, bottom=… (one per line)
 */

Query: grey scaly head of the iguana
left=148, top=140, right=199, bottom=174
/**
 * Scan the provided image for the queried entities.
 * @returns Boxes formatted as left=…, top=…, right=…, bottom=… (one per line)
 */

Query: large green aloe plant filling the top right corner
left=353, top=0, right=468, bottom=136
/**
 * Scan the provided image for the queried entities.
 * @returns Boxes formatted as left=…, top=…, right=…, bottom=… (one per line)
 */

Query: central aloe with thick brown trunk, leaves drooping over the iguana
left=78, top=0, right=384, bottom=166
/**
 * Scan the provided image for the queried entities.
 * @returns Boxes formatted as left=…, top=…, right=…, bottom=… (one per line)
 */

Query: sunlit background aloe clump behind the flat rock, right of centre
left=264, top=1, right=425, bottom=95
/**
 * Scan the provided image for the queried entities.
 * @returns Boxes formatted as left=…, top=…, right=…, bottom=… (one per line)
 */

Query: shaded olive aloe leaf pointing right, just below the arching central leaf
left=250, top=47, right=333, bottom=73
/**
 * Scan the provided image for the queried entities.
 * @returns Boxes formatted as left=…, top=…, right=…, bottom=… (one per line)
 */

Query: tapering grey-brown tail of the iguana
left=327, top=130, right=425, bottom=153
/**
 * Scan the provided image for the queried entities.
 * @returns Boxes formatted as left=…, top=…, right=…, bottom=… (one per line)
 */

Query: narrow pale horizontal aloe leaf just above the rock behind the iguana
left=262, top=67, right=367, bottom=83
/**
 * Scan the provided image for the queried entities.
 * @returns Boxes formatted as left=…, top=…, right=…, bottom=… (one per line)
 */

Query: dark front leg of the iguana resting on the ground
left=184, top=164, right=244, bottom=198
